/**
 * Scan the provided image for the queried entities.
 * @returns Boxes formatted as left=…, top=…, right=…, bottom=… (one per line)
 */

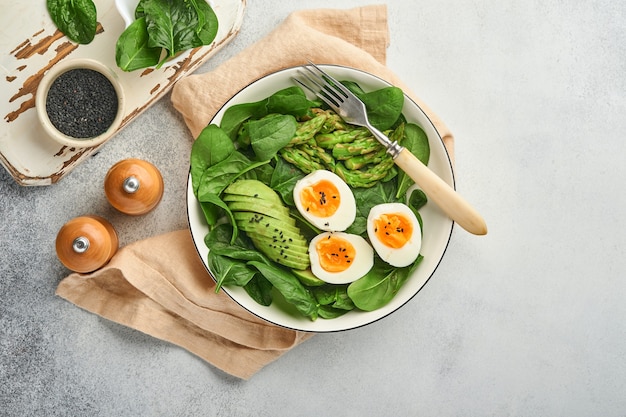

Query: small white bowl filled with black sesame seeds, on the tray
left=35, top=59, right=124, bottom=148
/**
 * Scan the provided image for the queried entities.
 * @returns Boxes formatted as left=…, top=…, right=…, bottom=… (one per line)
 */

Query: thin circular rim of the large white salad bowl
left=186, top=64, right=456, bottom=333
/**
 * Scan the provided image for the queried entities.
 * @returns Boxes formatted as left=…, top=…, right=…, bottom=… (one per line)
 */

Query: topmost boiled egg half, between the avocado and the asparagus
left=293, top=170, right=356, bottom=232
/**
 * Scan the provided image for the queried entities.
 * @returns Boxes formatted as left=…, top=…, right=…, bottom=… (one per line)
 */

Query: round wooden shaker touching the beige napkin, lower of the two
left=56, top=216, right=119, bottom=273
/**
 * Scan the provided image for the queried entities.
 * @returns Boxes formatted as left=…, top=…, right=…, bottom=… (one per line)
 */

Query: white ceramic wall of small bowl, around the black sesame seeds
left=35, top=58, right=125, bottom=148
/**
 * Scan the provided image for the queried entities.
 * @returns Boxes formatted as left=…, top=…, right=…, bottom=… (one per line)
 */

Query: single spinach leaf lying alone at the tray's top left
left=46, top=0, right=98, bottom=44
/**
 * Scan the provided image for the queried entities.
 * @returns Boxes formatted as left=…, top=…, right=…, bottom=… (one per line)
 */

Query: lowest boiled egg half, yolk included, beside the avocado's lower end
left=309, top=232, right=374, bottom=284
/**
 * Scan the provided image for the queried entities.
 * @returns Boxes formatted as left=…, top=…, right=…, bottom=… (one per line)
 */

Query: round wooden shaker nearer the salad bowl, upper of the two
left=104, top=158, right=163, bottom=216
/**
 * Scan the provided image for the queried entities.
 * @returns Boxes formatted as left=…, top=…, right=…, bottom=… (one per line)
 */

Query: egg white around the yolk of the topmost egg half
left=293, top=170, right=356, bottom=232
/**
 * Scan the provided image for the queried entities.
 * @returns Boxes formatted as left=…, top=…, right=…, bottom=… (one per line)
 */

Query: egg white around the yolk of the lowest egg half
left=309, top=232, right=374, bottom=284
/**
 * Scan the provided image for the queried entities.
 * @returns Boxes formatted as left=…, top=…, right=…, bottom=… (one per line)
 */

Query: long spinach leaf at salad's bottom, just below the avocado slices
left=248, top=261, right=318, bottom=320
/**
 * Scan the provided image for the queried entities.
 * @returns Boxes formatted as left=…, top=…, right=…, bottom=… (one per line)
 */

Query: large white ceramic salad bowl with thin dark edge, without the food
left=187, top=65, right=454, bottom=332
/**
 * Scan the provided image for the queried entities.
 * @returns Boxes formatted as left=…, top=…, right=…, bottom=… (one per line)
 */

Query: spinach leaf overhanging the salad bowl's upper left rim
left=190, top=124, right=235, bottom=197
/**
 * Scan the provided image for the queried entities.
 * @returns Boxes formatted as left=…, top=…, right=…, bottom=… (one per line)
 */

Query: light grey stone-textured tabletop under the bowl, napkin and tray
left=0, top=0, right=626, bottom=417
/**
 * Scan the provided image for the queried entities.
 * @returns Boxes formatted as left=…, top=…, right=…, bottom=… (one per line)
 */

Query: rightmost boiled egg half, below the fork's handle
left=367, top=203, right=422, bottom=267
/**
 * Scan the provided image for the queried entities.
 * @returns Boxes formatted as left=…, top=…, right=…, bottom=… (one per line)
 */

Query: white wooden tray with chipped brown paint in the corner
left=0, top=0, right=246, bottom=186
